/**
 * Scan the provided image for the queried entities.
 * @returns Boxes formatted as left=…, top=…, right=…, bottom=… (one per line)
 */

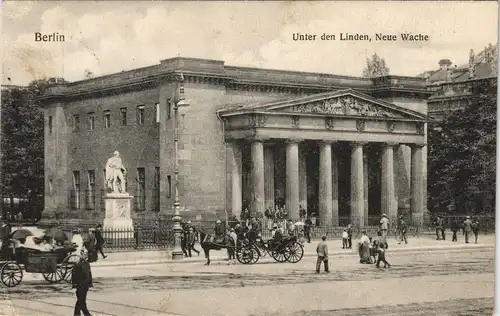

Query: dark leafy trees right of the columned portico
left=428, top=78, right=497, bottom=213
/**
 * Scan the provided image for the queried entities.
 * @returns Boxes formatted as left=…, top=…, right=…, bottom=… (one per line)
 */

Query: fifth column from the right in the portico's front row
left=286, top=142, right=299, bottom=220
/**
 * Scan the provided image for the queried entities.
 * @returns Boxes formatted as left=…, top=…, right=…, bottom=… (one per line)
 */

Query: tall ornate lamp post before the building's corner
left=172, top=73, right=189, bottom=260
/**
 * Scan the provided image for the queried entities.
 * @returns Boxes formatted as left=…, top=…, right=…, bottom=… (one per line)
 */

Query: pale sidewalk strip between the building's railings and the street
left=92, top=235, right=495, bottom=267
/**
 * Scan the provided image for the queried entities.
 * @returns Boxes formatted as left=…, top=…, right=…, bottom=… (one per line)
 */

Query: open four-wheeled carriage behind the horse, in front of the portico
left=236, top=236, right=304, bottom=264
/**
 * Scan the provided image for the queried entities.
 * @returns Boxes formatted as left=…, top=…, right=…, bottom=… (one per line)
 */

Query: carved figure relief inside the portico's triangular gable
left=287, top=96, right=401, bottom=117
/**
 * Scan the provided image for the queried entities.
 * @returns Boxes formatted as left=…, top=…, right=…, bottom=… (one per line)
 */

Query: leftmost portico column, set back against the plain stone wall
left=229, top=142, right=243, bottom=218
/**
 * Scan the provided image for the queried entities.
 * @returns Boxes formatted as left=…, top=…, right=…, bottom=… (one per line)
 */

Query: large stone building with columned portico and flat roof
left=43, top=58, right=430, bottom=226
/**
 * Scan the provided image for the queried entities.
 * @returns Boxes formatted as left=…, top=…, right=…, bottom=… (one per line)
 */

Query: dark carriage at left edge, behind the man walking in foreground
left=0, top=239, right=80, bottom=287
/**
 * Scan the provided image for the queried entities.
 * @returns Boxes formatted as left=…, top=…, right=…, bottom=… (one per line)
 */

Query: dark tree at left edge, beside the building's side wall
left=1, top=80, right=46, bottom=217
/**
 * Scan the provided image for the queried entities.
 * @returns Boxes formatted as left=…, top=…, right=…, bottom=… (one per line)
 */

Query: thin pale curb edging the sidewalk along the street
left=93, top=245, right=495, bottom=268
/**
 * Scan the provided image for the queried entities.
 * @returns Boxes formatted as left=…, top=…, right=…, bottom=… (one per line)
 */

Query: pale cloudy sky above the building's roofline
left=1, top=0, right=498, bottom=85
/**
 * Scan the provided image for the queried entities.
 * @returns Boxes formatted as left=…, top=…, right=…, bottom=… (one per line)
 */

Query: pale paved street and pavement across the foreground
left=0, top=235, right=495, bottom=316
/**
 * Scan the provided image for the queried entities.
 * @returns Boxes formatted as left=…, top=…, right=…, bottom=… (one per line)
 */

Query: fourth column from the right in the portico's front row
left=319, top=142, right=332, bottom=227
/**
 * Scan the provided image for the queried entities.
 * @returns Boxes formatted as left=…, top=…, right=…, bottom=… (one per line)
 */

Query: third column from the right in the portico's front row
left=351, top=143, right=365, bottom=228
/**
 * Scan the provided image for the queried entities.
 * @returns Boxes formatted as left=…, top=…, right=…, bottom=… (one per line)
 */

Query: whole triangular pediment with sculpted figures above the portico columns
left=261, top=90, right=425, bottom=119
